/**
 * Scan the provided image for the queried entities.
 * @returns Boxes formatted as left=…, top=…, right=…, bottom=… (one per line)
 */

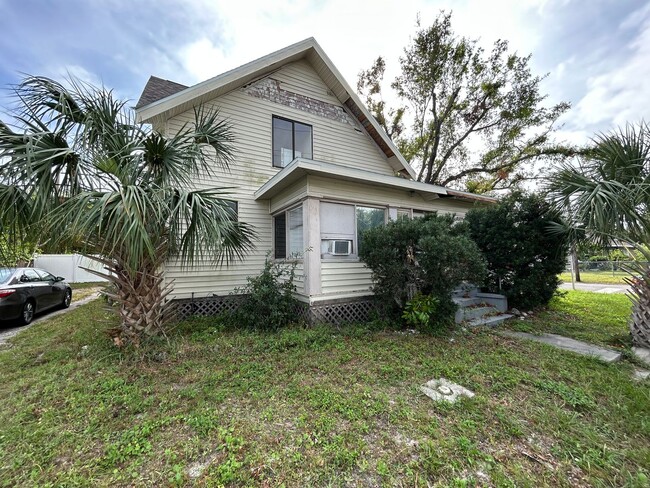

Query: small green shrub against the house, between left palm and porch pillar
left=224, top=256, right=300, bottom=330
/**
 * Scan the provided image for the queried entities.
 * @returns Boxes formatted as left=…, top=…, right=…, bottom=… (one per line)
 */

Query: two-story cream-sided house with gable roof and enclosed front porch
left=136, top=38, right=492, bottom=321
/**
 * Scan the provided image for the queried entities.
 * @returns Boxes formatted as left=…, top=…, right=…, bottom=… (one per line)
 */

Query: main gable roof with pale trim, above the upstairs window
left=136, top=37, right=417, bottom=179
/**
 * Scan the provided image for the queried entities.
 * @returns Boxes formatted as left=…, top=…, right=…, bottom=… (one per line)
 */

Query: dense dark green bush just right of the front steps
left=465, top=192, right=568, bottom=308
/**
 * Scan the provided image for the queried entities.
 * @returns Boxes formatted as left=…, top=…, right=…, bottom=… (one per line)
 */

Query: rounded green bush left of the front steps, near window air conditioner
left=360, top=214, right=486, bottom=328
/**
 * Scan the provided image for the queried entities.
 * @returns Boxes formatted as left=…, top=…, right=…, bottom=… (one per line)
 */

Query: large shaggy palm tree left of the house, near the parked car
left=0, top=77, right=255, bottom=345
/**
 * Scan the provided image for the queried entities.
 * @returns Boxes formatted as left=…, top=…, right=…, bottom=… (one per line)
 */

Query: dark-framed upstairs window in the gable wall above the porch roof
left=273, top=115, right=313, bottom=168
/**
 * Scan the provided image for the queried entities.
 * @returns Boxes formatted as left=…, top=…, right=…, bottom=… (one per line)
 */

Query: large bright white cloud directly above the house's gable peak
left=173, top=0, right=546, bottom=86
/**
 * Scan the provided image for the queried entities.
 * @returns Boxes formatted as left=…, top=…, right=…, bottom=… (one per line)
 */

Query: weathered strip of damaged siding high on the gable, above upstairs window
left=242, top=78, right=357, bottom=127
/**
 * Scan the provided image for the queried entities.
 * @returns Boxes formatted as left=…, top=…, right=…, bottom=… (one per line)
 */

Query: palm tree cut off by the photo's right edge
left=549, top=122, right=650, bottom=347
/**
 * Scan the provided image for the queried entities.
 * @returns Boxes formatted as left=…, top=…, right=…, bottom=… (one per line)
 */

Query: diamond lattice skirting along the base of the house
left=170, top=295, right=379, bottom=325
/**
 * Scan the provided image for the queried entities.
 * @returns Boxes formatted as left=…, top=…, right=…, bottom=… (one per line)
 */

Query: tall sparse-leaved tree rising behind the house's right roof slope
left=357, top=12, right=575, bottom=192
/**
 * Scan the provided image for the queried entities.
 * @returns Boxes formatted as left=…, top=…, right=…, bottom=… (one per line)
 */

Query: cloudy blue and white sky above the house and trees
left=0, top=0, right=650, bottom=147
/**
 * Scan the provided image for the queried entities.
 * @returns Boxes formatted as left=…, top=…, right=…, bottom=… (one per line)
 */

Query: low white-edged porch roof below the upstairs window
left=254, top=158, right=496, bottom=203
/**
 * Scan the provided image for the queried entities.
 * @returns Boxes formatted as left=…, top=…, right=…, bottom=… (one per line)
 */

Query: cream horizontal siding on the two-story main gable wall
left=166, top=61, right=393, bottom=298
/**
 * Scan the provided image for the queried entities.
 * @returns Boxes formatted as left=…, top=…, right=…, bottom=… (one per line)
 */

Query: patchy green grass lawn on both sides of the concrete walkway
left=0, top=294, right=650, bottom=487
